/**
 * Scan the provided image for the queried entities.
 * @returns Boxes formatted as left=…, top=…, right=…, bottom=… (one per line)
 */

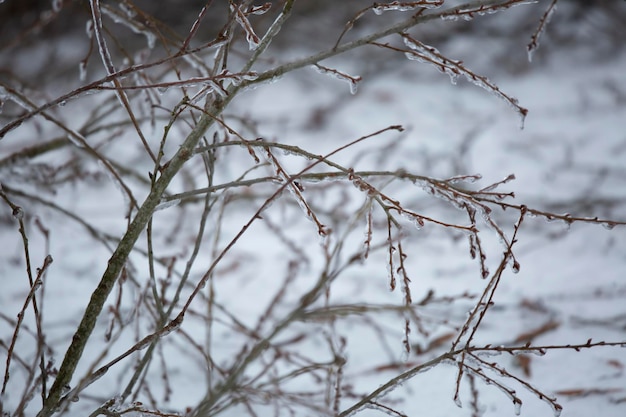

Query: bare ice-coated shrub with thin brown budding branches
left=0, top=0, right=626, bottom=417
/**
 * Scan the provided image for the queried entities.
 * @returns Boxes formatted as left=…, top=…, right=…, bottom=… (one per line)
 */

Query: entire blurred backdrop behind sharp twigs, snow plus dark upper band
left=0, top=0, right=626, bottom=417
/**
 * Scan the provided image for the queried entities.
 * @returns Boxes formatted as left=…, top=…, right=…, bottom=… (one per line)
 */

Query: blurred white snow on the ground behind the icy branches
left=0, top=2, right=626, bottom=417
